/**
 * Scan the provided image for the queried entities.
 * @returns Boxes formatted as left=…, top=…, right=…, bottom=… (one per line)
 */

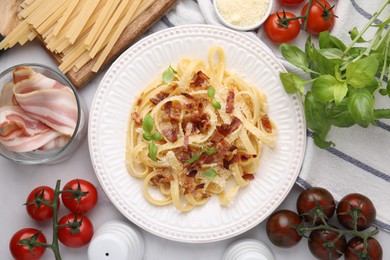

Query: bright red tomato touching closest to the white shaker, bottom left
left=58, top=213, right=93, bottom=248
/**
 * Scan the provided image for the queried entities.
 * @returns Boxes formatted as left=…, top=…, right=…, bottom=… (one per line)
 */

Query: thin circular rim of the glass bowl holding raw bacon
left=0, top=62, right=83, bottom=165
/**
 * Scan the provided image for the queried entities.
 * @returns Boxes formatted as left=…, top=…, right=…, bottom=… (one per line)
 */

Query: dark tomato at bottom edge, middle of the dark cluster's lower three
left=308, top=229, right=347, bottom=259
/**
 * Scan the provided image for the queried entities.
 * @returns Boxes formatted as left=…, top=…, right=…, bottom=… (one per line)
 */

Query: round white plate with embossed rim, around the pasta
left=88, top=25, right=306, bottom=243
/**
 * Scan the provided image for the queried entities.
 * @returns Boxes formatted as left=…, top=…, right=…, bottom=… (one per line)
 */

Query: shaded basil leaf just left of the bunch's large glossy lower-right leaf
left=328, top=98, right=355, bottom=127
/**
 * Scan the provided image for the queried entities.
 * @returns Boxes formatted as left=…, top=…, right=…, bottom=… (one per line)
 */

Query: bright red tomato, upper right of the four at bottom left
left=61, top=179, right=98, bottom=214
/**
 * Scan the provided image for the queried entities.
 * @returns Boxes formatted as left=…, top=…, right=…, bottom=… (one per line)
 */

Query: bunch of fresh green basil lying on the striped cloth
left=280, top=0, right=390, bottom=148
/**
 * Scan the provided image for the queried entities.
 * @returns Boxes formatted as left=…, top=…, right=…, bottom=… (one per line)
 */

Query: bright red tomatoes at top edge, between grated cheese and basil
left=264, top=0, right=336, bottom=44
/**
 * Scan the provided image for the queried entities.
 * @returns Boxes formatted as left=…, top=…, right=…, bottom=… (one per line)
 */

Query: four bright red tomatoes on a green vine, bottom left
left=9, top=179, right=98, bottom=260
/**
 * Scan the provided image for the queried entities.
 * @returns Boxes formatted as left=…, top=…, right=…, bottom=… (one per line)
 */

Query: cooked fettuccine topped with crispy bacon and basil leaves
left=126, top=47, right=277, bottom=211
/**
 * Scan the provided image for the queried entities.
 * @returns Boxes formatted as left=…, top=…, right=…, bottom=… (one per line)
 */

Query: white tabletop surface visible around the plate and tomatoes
left=0, top=40, right=390, bottom=260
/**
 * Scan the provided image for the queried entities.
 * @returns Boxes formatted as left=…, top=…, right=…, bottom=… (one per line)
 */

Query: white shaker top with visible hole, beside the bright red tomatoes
left=88, top=221, right=145, bottom=260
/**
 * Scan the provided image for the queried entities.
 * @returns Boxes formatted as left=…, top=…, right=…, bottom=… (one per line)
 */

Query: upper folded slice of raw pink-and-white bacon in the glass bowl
left=14, top=72, right=77, bottom=136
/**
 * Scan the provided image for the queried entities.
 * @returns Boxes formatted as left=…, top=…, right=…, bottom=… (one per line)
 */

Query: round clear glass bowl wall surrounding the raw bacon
left=0, top=63, right=88, bottom=165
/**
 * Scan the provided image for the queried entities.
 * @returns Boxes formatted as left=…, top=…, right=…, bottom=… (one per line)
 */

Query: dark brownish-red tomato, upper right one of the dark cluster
left=337, top=193, right=376, bottom=230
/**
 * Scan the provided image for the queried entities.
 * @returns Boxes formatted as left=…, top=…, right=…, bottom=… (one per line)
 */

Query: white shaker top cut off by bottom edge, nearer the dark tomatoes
left=222, top=239, right=275, bottom=260
